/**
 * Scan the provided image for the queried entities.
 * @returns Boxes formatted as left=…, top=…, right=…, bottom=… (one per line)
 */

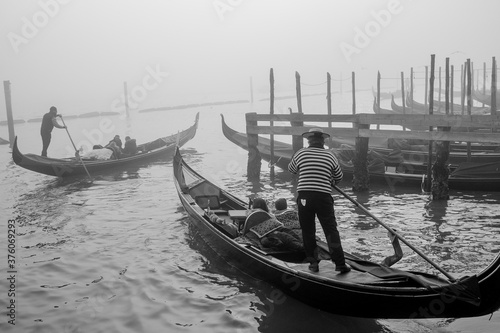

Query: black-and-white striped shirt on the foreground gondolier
left=288, top=147, right=343, bottom=193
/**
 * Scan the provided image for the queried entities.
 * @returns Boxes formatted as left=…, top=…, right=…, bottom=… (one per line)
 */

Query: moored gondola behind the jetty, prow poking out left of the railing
left=221, top=115, right=500, bottom=191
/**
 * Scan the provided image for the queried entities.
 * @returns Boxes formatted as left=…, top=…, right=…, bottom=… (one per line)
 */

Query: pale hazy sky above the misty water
left=0, top=0, right=500, bottom=119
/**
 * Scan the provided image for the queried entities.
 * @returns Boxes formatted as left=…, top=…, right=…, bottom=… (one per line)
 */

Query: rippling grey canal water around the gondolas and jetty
left=0, top=91, right=500, bottom=332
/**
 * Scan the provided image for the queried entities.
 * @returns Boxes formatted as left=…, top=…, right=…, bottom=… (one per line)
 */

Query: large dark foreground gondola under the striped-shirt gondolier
left=173, top=150, right=500, bottom=318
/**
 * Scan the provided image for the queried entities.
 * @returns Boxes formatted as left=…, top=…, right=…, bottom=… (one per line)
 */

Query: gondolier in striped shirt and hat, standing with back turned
left=288, top=128, right=351, bottom=273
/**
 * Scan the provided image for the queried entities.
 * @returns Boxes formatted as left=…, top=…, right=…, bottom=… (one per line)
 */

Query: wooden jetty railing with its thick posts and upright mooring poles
left=246, top=55, right=500, bottom=200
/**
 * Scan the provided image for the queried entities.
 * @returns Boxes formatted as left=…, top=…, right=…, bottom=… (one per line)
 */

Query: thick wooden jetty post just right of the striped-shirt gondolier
left=352, top=123, right=370, bottom=192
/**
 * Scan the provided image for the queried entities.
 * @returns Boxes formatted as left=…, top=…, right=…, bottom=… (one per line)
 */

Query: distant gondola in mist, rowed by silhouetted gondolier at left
left=12, top=114, right=199, bottom=177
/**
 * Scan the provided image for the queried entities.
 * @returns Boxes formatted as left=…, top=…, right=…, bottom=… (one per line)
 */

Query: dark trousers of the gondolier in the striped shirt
left=297, top=191, right=345, bottom=266
